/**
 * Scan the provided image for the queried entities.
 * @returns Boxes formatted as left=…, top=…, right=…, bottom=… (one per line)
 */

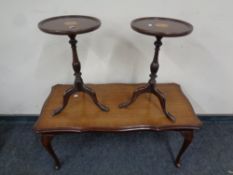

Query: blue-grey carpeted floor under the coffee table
left=0, top=122, right=233, bottom=175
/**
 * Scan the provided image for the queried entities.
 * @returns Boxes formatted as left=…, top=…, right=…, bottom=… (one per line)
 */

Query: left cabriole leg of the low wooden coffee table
left=41, top=134, right=61, bottom=170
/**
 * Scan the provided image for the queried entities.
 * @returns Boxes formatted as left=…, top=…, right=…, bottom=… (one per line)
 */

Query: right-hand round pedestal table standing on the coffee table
left=119, top=17, right=193, bottom=122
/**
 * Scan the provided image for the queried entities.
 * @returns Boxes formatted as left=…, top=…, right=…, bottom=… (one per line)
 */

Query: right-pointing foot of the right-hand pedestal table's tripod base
left=152, top=88, right=176, bottom=122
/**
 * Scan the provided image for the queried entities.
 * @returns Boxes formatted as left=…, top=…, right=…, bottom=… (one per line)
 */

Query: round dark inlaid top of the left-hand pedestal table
left=38, top=15, right=101, bottom=35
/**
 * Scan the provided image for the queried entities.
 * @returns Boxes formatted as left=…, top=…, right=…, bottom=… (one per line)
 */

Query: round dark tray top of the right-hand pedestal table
left=131, top=17, right=193, bottom=37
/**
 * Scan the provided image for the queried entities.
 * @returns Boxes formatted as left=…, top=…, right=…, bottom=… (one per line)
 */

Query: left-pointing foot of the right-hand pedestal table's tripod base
left=119, top=85, right=150, bottom=108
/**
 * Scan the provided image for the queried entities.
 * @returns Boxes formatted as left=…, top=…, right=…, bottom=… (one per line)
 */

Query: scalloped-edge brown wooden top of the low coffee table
left=34, top=83, right=202, bottom=133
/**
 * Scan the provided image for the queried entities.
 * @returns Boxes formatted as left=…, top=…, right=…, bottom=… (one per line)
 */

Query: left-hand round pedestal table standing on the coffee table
left=38, top=15, right=109, bottom=116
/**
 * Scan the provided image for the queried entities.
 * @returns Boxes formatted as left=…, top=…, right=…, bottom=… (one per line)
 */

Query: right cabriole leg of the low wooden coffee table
left=175, top=130, right=193, bottom=168
